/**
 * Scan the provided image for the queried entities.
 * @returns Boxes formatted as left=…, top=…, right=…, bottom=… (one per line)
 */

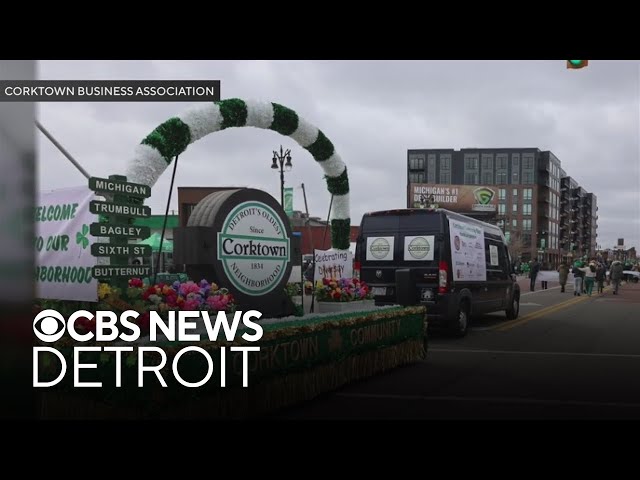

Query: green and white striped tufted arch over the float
left=126, top=98, right=351, bottom=250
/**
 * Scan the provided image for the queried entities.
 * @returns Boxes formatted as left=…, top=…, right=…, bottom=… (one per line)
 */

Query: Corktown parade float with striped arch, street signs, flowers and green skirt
left=36, top=99, right=426, bottom=418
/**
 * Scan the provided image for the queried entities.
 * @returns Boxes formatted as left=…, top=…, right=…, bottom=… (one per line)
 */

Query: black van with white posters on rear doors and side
left=355, top=209, right=520, bottom=336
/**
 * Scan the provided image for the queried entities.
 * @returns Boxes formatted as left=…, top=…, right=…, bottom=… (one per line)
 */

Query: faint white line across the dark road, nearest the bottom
left=335, top=393, right=640, bottom=408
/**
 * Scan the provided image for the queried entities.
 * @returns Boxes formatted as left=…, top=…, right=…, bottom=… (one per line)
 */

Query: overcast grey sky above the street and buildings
left=38, top=60, right=640, bottom=251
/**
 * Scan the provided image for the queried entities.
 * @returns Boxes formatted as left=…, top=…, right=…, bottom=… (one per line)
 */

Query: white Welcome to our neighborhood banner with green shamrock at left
left=34, top=186, right=98, bottom=302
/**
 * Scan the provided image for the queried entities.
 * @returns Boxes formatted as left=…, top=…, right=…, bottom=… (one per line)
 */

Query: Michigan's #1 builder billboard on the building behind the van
left=407, top=183, right=498, bottom=213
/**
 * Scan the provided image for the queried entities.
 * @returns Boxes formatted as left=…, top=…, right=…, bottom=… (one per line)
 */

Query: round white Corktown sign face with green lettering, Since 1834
left=218, top=201, right=290, bottom=296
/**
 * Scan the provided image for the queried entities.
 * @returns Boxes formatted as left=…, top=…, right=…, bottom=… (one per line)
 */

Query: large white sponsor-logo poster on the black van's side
left=449, top=218, right=487, bottom=281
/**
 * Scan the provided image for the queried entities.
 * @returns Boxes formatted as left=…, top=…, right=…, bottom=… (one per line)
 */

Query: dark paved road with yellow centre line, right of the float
left=276, top=284, right=640, bottom=419
